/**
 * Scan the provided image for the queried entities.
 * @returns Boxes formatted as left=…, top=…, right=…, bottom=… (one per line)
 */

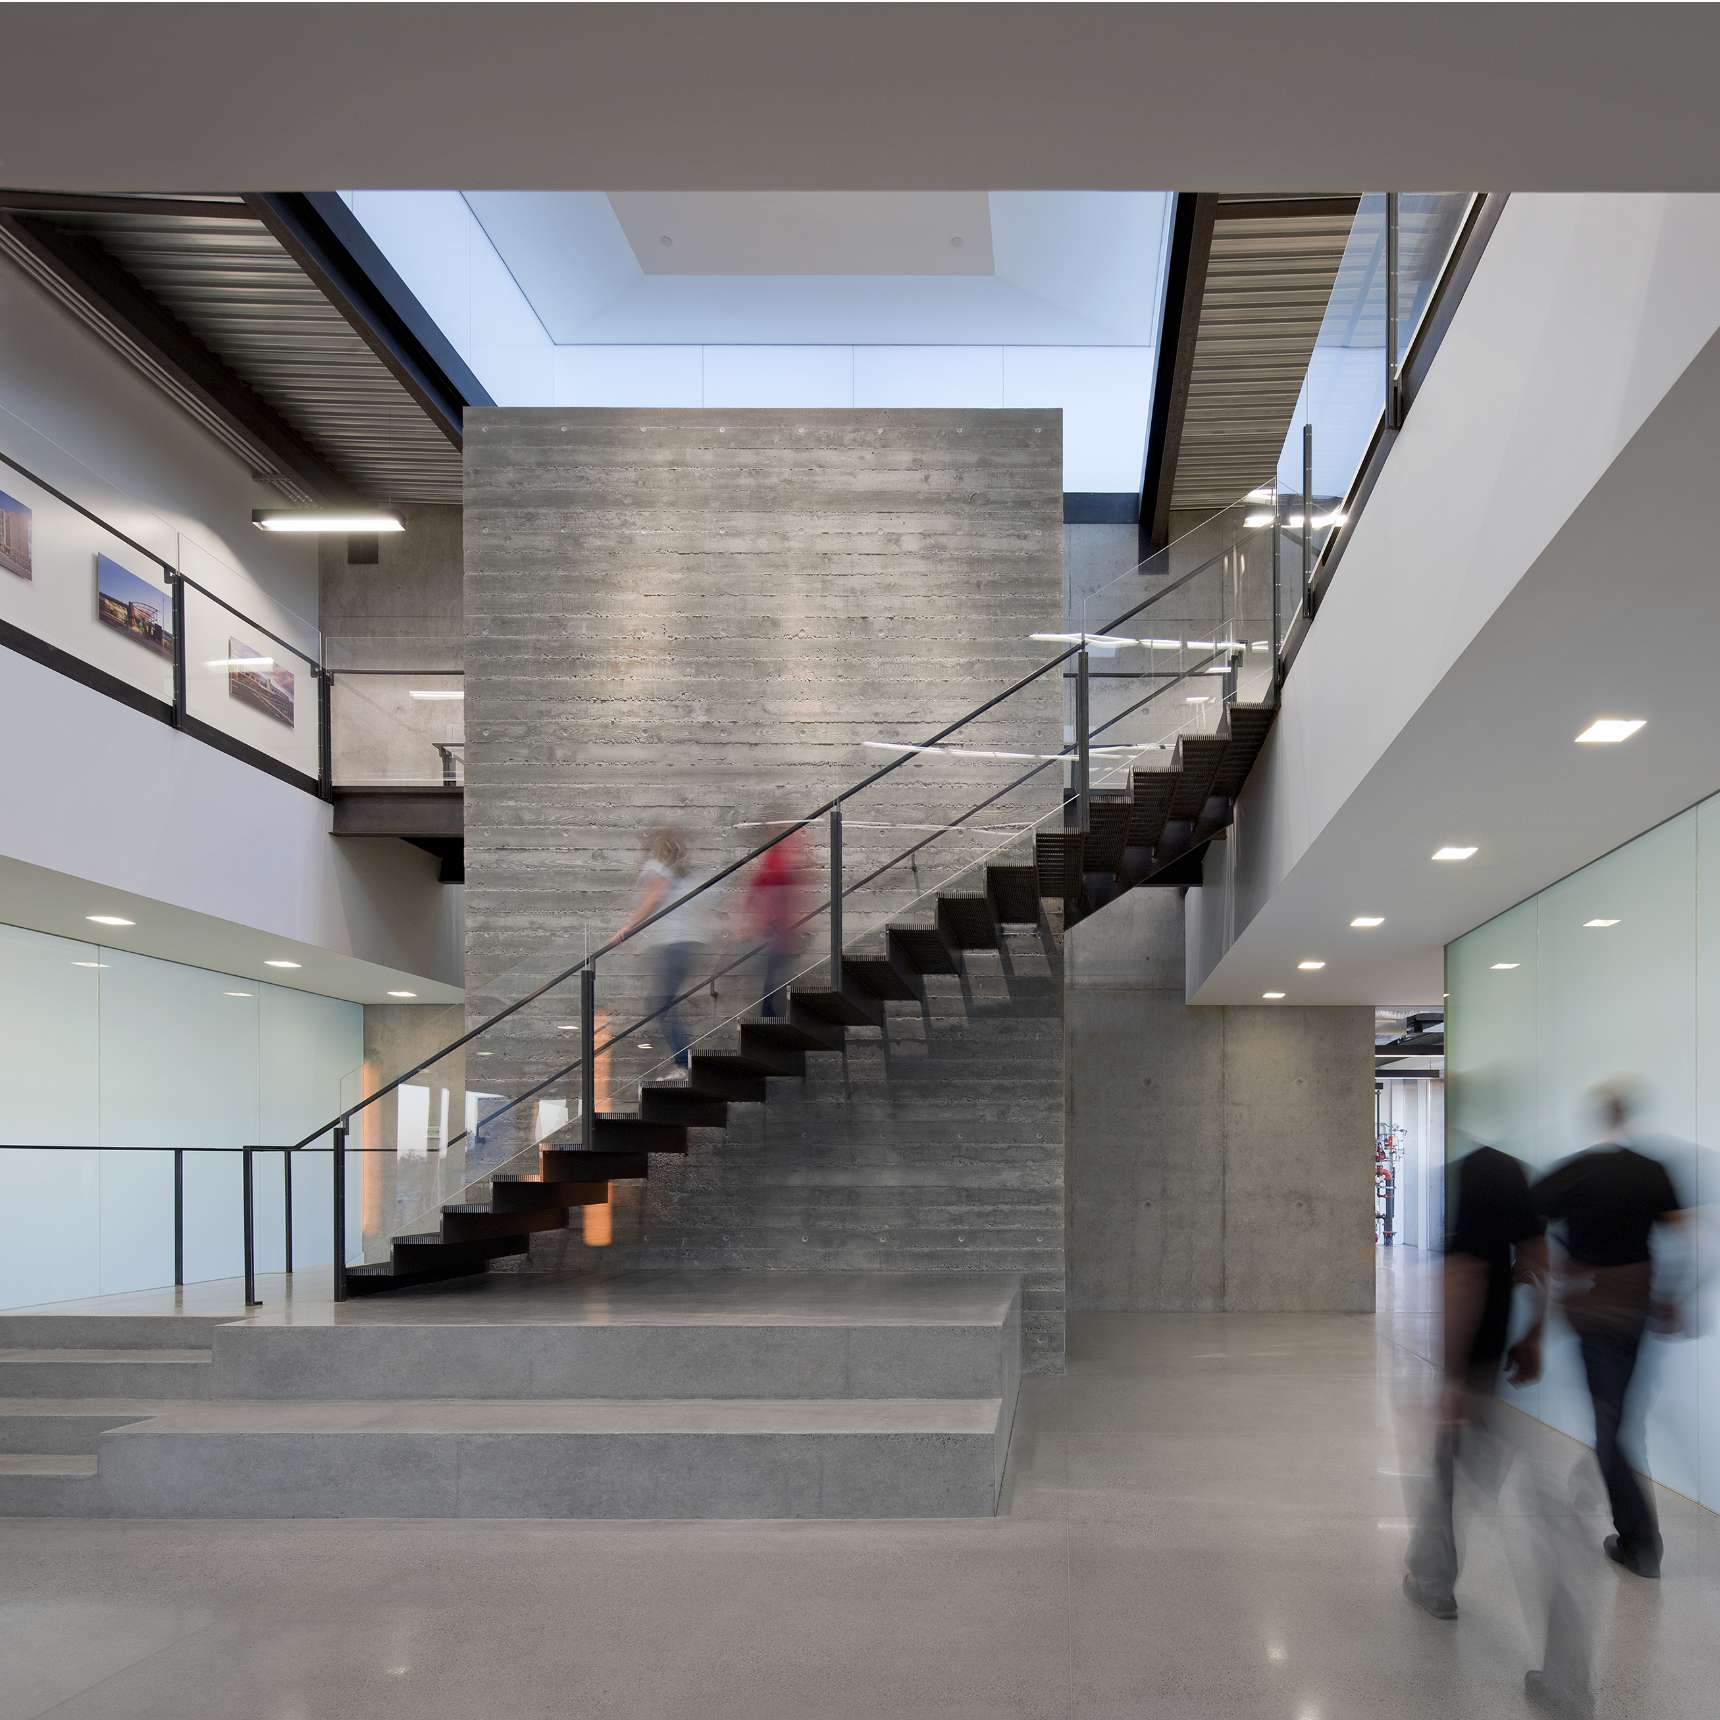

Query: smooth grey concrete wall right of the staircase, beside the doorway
left=1065, top=889, right=1374, bottom=1312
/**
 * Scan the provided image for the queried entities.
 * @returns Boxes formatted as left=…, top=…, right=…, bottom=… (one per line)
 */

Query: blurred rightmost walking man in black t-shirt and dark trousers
left=1533, top=1089, right=1682, bottom=1577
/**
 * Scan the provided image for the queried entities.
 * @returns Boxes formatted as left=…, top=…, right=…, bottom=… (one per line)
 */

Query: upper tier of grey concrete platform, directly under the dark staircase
left=213, top=1271, right=1020, bottom=1404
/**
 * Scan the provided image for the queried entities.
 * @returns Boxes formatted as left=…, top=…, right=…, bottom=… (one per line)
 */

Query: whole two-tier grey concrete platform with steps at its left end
left=0, top=1273, right=1020, bottom=1519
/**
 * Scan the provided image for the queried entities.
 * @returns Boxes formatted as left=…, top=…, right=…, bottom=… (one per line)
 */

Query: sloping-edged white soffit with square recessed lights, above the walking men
left=1192, top=323, right=1720, bottom=1004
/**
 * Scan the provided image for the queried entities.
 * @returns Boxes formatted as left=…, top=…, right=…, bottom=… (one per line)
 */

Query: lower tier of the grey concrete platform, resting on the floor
left=97, top=1397, right=1013, bottom=1519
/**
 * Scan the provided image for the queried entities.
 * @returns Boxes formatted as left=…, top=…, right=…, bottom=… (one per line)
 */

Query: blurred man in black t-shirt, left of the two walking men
left=1404, top=1147, right=1546, bottom=1619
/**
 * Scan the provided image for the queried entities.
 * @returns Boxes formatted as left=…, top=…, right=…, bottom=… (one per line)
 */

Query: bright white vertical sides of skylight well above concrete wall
left=346, top=191, right=1161, bottom=492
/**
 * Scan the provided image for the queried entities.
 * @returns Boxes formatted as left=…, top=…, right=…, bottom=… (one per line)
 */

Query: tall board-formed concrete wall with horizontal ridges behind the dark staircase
left=464, top=409, right=1065, bottom=1355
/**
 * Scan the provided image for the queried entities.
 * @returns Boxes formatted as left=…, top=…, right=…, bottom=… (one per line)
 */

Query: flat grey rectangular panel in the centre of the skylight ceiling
left=609, top=191, right=991, bottom=275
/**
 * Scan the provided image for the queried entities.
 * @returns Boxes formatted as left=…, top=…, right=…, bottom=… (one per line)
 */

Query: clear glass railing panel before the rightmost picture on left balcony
left=182, top=545, right=322, bottom=781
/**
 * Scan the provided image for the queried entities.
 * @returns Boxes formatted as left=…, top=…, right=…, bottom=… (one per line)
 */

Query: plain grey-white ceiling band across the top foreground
left=5, top=3, right=1720, bottom=191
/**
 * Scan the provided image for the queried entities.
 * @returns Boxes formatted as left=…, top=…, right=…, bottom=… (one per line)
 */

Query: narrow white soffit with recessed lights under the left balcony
left=0, top=855, right=464, bottom=1004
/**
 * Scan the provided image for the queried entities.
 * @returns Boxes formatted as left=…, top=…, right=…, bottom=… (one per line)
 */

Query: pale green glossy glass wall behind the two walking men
left=1447, top=800, right=1720, bottom=1508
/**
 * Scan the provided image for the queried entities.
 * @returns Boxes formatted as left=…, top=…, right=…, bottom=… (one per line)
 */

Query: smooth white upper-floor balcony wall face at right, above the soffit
left=1187, top=194, right=1720, bottom=1001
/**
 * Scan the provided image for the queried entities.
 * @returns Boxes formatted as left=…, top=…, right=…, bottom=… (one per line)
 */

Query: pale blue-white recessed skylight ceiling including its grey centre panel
left=466, top=191, right=1171, bottom=346
